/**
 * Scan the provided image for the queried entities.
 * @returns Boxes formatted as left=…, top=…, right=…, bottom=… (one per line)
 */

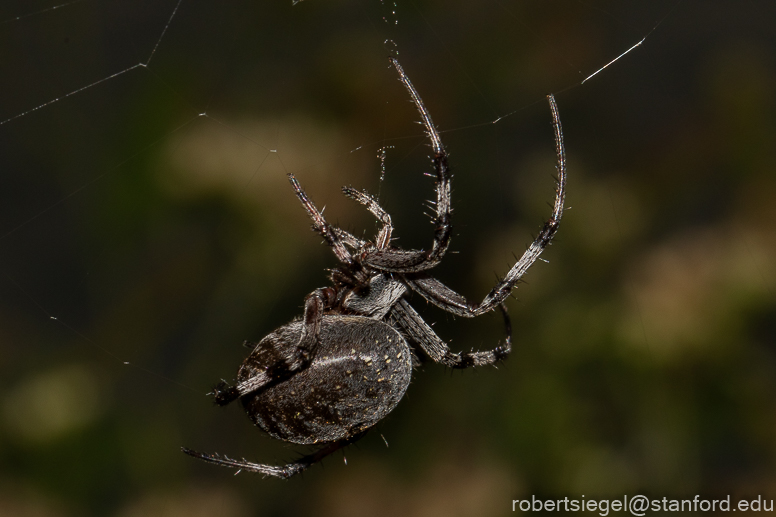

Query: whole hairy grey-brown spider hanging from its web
left=182, top=58, right=566, bottom=478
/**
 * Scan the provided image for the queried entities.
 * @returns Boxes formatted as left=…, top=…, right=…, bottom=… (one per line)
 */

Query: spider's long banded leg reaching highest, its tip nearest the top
left=361, top=58, right=452, bottom=273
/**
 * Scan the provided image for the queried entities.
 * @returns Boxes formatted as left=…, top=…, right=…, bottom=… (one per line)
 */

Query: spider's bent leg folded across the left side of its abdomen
left=213, top=287, right=335, bottom=406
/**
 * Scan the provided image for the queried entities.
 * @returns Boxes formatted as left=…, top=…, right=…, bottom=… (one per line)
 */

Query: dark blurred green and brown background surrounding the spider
left=0, top=0, right=776, bottom=517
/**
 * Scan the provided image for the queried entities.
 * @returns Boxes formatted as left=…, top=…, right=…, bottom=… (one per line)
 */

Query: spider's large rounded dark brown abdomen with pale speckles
left=238, top=315, right=412, bottom=444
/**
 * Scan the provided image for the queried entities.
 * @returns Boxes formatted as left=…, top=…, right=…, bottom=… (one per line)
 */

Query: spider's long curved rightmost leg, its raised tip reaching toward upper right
left=407, top=95, right=566, bottom=318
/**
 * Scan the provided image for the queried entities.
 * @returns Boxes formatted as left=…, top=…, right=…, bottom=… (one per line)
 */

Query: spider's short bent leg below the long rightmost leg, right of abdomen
left=389, top=299, right=512, bottom=369
